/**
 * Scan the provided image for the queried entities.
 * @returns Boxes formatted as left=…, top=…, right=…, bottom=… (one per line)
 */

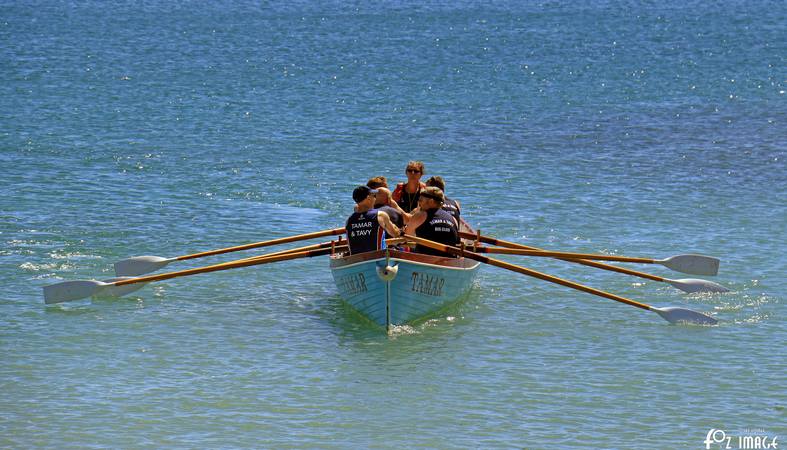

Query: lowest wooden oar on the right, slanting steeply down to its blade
left=406, top=235, right=718, bottom=325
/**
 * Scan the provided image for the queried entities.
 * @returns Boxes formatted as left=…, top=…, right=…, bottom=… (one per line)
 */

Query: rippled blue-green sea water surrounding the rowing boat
left=0, top=0, right=787, bottom=449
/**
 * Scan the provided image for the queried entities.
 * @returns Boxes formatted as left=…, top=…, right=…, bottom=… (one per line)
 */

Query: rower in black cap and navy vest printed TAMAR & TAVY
left=345, top=186, right=401, bottom=255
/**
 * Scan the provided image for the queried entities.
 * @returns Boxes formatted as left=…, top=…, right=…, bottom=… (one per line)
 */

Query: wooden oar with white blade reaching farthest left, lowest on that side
left=44, top=247, right=345, bottom=304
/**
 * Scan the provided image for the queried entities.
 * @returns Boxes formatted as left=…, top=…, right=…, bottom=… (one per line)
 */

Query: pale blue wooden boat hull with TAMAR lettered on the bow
left=330, top=248, right=480, bottom=330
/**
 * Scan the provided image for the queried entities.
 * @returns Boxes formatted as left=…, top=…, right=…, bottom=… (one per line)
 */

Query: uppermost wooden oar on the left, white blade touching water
left=115, top=228, right=345, bottom=277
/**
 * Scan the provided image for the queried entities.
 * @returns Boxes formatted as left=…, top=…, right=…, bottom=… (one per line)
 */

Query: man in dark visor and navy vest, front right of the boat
left=407, top=186, right=459, bottom=256
